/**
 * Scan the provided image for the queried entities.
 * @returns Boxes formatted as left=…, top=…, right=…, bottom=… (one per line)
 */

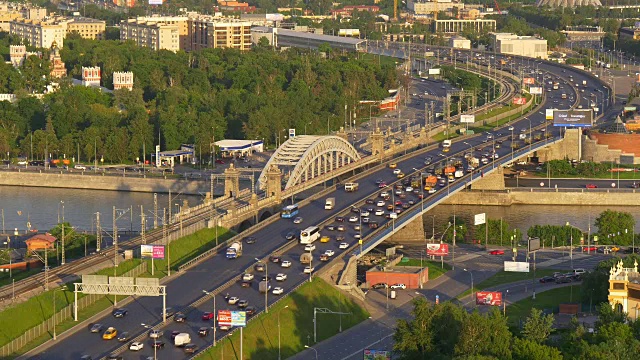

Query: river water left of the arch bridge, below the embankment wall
left=0, top=186, right=202, bottom=233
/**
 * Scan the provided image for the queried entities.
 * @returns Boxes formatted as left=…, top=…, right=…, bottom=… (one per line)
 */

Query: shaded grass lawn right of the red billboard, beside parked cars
left=507, top=285, right=582, bottom=323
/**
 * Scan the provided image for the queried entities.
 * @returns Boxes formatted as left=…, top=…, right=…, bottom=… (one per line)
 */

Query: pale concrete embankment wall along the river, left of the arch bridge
left=0, top=172, right=210, bottom=195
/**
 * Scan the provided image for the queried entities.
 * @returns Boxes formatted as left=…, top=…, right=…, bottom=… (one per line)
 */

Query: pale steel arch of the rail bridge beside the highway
left=258, top=135, right=360, bottom=190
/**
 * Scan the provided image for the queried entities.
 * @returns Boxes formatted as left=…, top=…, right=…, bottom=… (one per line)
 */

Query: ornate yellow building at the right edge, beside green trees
left=608, top=260, right=640, bottom=321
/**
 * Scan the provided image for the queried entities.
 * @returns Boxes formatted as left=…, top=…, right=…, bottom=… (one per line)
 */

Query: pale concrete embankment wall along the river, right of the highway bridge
left=443, top=189, right=640, bottom=206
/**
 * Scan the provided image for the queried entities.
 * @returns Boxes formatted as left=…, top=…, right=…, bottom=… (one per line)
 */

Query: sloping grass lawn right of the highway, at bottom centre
left=200, top=278, right=369, bottom=360
